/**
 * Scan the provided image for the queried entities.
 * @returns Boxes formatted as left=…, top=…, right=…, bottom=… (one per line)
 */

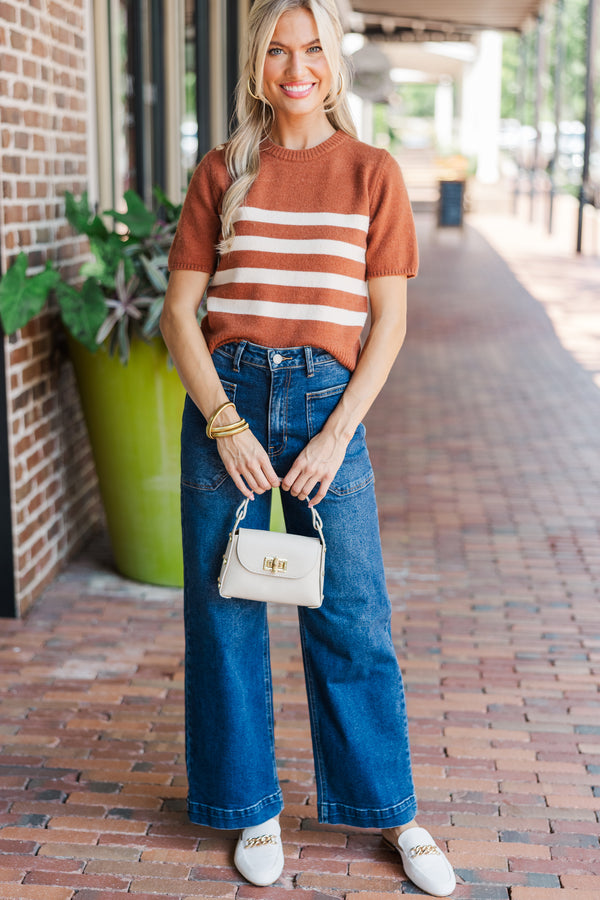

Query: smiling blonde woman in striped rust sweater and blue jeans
left=161, top=0, right=455, bottom=895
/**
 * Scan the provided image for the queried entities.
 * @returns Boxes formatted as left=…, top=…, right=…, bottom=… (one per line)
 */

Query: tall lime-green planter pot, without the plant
left=69, top=338, right=185, bottom=587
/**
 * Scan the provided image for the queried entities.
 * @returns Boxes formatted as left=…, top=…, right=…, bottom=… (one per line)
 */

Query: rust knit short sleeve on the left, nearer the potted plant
left=169, top=150, right=226, bottom=275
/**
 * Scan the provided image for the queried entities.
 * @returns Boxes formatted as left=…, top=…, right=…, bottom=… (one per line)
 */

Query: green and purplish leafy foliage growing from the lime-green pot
left=0, top=188, right=181, bottom=364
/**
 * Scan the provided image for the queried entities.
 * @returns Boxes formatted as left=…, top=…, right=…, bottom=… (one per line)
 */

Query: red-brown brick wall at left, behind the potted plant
left=0, top=0, right=101, bottom=613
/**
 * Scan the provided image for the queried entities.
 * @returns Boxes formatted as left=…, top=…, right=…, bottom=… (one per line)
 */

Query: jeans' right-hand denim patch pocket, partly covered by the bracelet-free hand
left=306, top=382, right=374, bottom=496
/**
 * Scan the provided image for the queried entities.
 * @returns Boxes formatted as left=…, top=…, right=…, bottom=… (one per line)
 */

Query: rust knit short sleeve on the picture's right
left=366, top=150, right=419, bottom=279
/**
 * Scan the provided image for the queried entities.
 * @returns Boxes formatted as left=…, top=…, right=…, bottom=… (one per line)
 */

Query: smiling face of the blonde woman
left=263, top=7, right=331, bottom=121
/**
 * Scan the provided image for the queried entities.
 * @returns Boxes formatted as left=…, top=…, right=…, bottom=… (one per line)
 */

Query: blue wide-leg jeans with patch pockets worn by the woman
left=181, top=341, right=416, bottom=828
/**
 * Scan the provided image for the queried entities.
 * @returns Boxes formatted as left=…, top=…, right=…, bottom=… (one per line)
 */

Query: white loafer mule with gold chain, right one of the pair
left=384, top=826, right=456, bottom=897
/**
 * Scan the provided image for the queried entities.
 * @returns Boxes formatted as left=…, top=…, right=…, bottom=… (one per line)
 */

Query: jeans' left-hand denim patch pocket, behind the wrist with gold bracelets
left=181, top=380, right=237, bottom=491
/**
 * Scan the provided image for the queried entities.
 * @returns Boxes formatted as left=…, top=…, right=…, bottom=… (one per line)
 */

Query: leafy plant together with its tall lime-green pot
left=0, top=190, right=185, bottom=585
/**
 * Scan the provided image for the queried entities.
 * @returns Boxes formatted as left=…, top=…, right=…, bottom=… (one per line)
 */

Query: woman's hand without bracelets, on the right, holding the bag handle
left=281, top=431, right=348, bottom=507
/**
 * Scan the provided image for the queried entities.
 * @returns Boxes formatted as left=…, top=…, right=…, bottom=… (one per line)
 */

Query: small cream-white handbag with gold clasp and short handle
left=218, top=500, right=326, bottom=608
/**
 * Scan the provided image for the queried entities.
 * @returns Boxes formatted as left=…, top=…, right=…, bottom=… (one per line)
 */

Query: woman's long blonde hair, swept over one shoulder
left=218, top=0, right=356, bottom=253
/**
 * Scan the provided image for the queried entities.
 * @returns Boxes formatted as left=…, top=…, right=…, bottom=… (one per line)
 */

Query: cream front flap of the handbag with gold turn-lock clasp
left=237, top=528, right=321, bottom=578
